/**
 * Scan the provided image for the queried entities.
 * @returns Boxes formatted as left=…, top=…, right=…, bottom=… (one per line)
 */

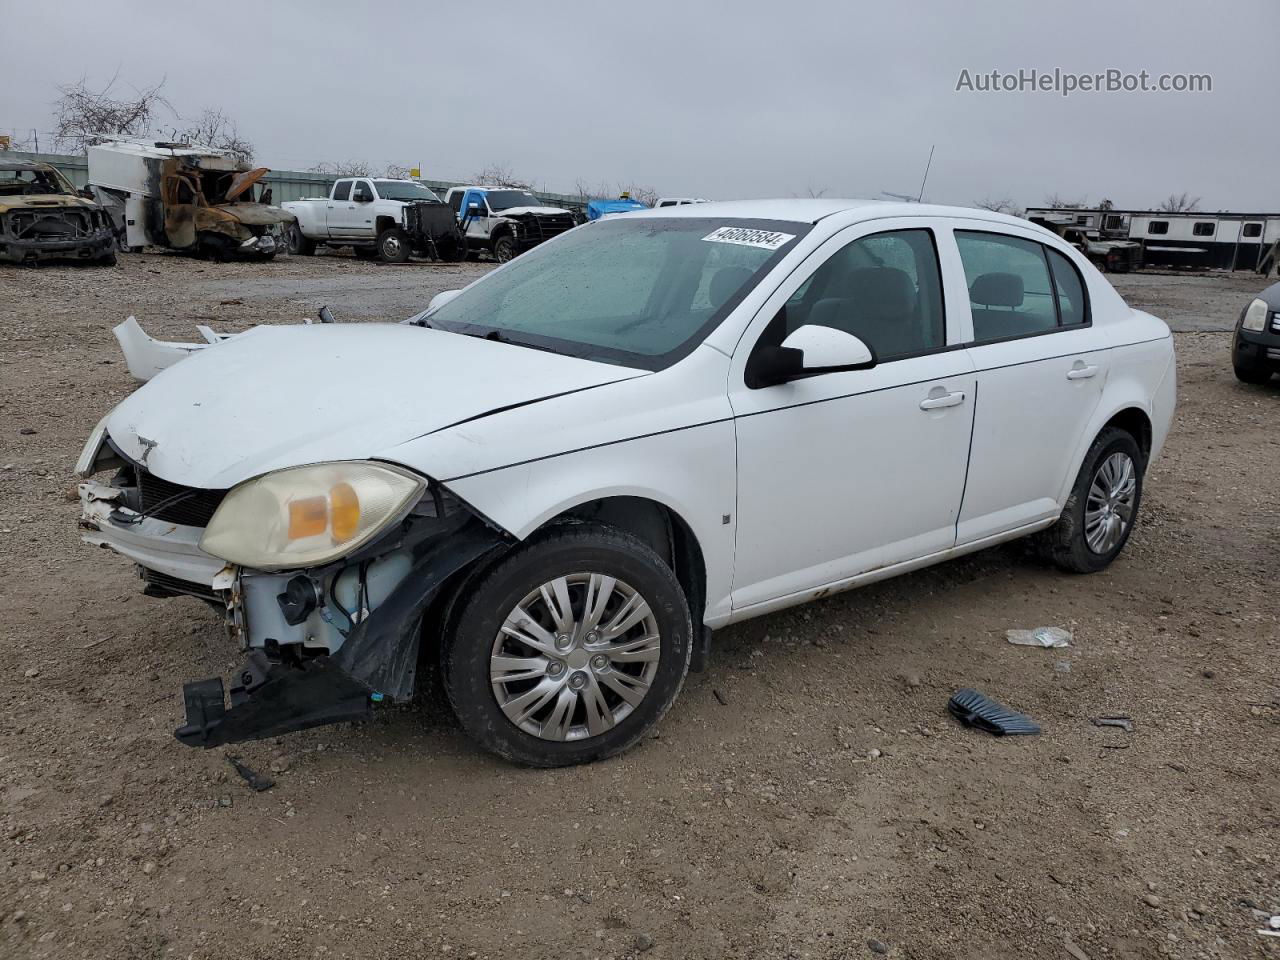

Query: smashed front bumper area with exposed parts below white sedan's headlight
left=79, top=465, right=509, bottom=748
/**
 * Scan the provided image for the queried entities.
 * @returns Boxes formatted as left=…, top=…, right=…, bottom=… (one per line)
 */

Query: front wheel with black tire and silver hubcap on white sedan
left=440, top=524, right=692, bottom=767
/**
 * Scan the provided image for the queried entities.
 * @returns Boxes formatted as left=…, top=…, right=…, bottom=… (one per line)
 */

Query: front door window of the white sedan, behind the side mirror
left=783, top=230, right=946, bottom=361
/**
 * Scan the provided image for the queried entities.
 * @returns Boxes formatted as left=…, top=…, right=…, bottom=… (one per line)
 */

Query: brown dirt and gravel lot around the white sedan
left=0, top=255, right=1280, bottom=960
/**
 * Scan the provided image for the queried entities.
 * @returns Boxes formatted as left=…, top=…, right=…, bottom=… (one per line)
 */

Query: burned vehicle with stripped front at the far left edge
left=0, top=160, right=115, bottom=266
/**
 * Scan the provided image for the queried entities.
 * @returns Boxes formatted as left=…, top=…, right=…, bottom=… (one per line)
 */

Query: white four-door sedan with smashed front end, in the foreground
left=78, top=200, right=1176, bottom=765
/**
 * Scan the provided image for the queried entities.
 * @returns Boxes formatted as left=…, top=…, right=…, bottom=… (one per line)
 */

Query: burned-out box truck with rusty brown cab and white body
left=88, top=140, right=293, bottom=260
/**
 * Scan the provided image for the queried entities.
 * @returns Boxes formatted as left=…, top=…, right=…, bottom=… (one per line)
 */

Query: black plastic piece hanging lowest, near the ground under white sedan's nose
left=174, top=650, right=381, bottom=748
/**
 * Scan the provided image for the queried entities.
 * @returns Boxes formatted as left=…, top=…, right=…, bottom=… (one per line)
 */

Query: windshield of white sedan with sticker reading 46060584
left=426, top=218, right=809, bottom=370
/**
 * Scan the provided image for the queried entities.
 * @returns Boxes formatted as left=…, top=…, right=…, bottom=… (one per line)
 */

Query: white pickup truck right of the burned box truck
left=288, top=177, right=467, bottom=264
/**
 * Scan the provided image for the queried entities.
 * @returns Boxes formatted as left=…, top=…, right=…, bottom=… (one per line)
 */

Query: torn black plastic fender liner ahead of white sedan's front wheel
left=174, top=522, right=511, bottom=748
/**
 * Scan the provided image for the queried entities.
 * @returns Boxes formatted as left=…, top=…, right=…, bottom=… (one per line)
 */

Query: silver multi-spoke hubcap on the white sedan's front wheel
left=489, top=573, right=662, bottom=740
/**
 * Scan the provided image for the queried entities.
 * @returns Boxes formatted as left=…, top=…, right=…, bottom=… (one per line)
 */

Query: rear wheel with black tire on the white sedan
left=1039, top=426, right=1147, bottom=573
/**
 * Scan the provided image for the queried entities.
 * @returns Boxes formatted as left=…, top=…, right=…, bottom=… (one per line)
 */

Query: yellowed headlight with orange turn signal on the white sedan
left=200, top=461, right=426, bottom=570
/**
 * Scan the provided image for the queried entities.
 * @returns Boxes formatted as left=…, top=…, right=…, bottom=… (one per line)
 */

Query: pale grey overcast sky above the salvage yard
left=0, top=0, right=1280, bottom=211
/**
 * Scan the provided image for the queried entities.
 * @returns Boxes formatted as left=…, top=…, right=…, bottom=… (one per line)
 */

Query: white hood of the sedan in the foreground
left=106, top=324, right=646, bottom=489
